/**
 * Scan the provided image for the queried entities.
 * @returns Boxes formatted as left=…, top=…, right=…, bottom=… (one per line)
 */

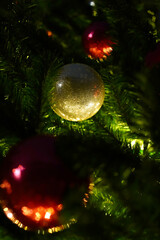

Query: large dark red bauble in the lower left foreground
left=0, top=136, right=88, bottom=233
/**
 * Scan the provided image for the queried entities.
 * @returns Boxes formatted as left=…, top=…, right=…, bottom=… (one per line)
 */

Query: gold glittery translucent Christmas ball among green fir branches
left=49, top=63, right=105, bottom=121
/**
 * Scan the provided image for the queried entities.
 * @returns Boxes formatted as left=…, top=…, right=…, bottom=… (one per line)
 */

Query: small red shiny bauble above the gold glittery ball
left=82, top=22, right=115, bottom=59
